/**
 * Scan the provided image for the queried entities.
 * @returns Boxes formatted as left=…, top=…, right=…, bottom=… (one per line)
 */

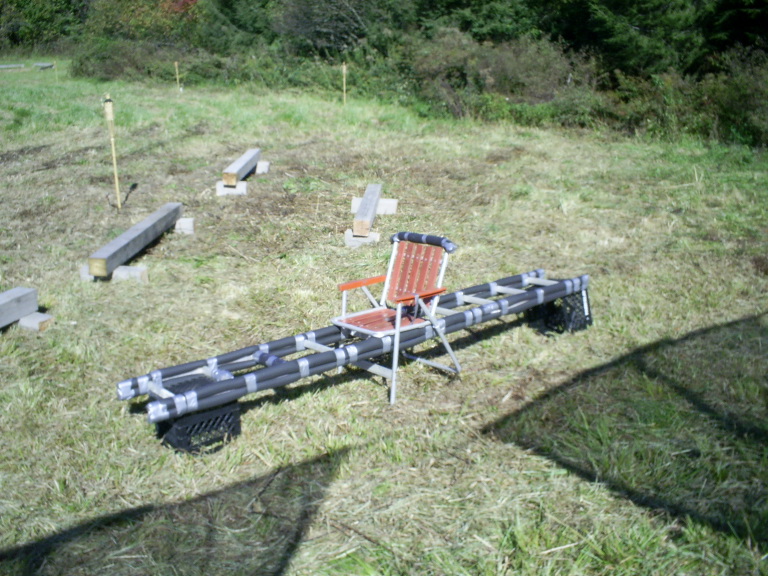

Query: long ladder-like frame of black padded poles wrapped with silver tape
left=117, top=269, right=589, bottom=422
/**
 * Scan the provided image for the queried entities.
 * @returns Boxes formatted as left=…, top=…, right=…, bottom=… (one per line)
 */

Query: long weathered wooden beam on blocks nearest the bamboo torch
left=88, top=202, right=183, bottom=278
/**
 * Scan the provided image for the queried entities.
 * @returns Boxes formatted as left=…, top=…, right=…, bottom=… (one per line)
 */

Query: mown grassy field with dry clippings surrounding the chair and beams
left=0, top=60, right=768, bottom=575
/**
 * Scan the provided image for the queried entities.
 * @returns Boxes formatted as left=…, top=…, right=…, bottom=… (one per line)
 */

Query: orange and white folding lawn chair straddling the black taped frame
left=331, top=232, right=461, bottom=404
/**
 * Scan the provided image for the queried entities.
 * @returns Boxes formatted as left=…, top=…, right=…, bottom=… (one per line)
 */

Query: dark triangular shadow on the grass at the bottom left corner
left=0, top=449, right=348, bottom=576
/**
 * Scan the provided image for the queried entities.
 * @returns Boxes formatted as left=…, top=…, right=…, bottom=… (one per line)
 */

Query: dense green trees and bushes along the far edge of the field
left=0, top=0, right=768, bottom=146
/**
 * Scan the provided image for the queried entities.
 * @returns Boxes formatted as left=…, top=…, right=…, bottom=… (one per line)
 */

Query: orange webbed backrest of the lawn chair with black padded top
left=381, top=232, right=456, bottom=305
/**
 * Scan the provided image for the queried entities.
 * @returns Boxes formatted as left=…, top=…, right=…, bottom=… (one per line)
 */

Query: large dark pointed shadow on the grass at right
left=484, top=314, right=768, bottom=551
